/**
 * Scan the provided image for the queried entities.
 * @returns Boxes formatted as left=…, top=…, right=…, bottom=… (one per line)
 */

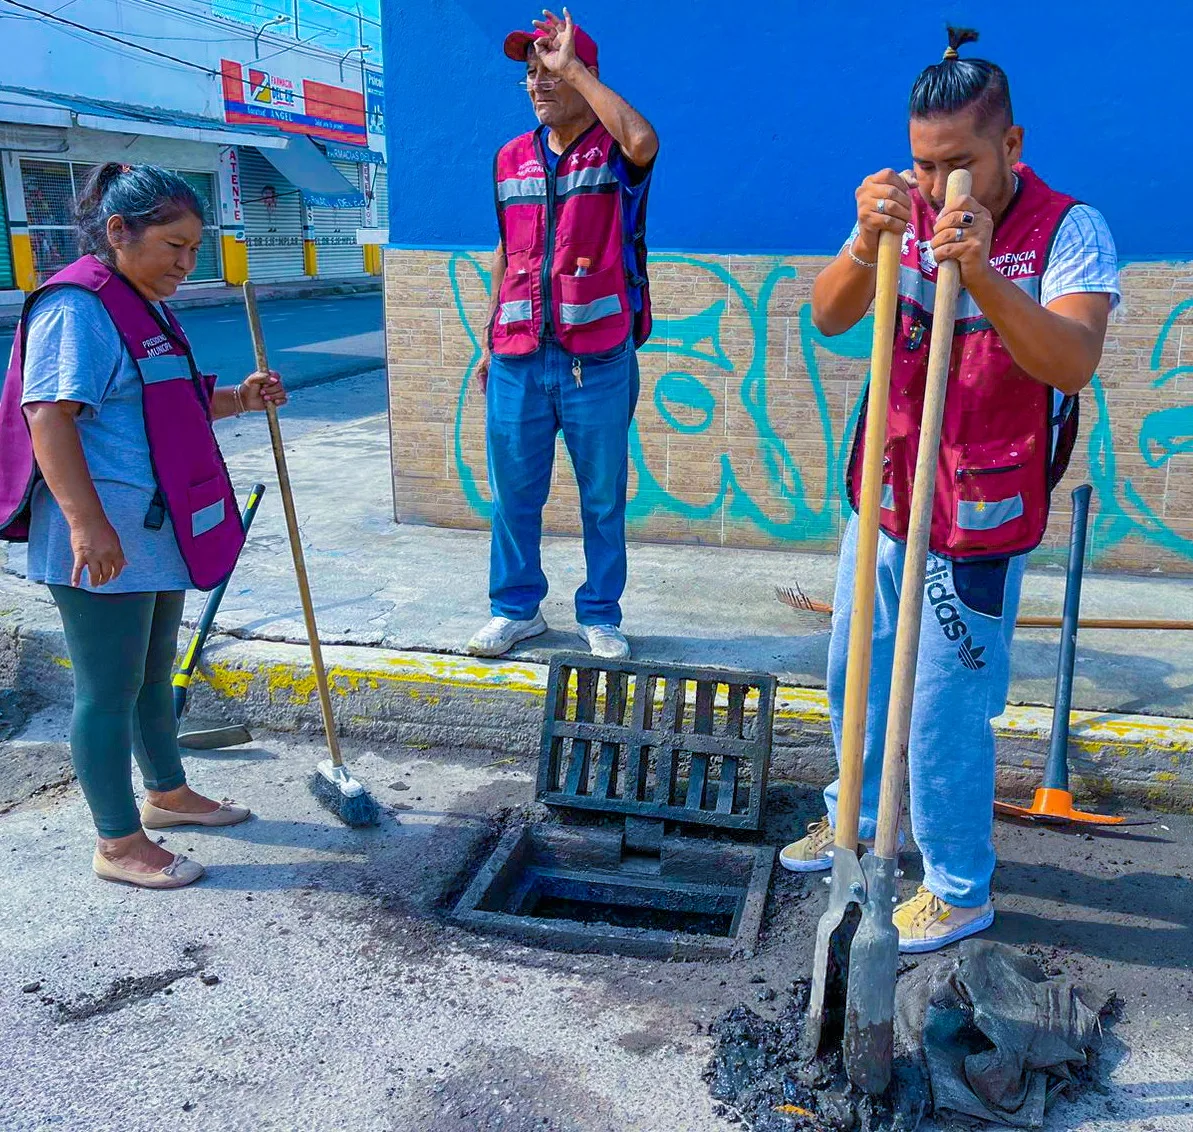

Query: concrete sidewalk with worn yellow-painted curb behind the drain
left=0, top=378, right=1193, bottom=805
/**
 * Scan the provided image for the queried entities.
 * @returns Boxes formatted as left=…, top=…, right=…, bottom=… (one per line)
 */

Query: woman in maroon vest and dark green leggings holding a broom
left=10, top=163, right=286, bottom=889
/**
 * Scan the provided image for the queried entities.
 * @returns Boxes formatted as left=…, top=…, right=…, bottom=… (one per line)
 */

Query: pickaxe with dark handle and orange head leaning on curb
left=994, top=483, right=1151, bottom=829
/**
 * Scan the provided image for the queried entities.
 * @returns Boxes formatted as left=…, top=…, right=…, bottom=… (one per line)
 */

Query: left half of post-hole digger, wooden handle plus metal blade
left=803, top=231, right=901, bottom=1058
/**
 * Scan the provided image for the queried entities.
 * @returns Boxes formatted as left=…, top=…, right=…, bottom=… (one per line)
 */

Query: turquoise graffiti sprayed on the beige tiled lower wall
left=447, top=253, right=1193, bottom=558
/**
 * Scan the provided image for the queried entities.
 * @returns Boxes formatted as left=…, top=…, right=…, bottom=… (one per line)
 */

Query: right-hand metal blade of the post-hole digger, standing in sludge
left=842, top=854, right=898, bottom=1095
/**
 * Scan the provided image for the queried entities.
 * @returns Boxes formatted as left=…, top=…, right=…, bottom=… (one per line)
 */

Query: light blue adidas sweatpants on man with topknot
left=824, top=515, right=1027, bottom=908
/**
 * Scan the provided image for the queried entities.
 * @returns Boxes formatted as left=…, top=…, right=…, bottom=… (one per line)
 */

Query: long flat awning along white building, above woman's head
left=0, top=85, right=288, bottom=149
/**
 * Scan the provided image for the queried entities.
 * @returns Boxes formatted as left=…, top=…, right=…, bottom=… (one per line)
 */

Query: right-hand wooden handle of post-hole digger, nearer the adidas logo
left=874, top=169, right=971, bottom=859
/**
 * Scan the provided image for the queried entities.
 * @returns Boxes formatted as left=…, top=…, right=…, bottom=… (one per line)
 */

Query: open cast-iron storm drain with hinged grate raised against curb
left=453, top=655, right=775, bottom=958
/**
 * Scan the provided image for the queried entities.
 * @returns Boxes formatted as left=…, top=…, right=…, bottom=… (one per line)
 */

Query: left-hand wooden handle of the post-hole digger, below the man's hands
left=836, top=231, right=901, bottom=853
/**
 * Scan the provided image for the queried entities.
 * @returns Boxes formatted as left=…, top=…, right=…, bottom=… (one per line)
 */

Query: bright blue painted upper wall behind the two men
left=382, top=0, right=1193, bottom=259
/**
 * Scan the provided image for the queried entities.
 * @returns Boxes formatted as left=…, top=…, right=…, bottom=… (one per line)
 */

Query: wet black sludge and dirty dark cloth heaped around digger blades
left=705, top=940, right=1117, bottom=1132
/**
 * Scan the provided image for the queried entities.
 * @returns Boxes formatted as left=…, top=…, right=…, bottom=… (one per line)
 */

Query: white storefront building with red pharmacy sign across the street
left=0, top=0, right=388, bottom=301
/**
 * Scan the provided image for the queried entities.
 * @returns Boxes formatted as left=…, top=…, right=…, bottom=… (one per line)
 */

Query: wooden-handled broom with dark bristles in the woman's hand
left=245, top=283, right=378, bottom=825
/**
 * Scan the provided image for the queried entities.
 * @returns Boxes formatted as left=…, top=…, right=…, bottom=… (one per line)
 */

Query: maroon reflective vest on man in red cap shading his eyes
left=489, top=123, right=650, bottom=355
